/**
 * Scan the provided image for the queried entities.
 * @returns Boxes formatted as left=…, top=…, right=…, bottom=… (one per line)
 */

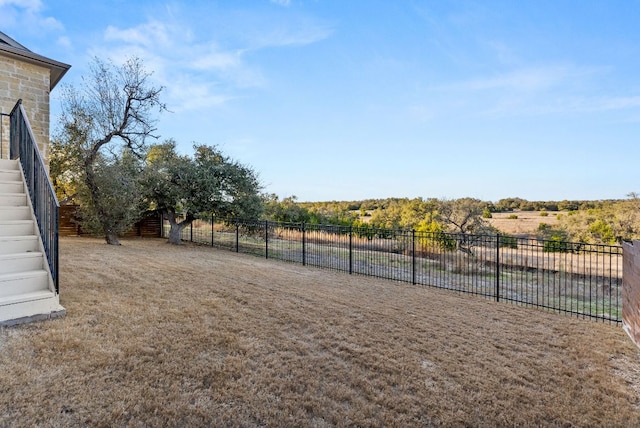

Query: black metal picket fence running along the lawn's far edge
left=163, top=218, right=622, bottom=323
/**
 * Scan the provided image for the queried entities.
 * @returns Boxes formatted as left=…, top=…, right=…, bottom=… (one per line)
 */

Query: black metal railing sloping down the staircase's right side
left=9, top=100, right=60, bottom=294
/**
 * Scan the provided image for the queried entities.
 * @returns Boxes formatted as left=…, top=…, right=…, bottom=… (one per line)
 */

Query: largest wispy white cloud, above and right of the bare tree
left=84, top=6, right=333, bottom=112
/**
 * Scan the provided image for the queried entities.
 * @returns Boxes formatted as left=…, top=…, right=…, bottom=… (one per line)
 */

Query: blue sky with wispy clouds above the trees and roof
left=0, top=0, right=640, bottom=201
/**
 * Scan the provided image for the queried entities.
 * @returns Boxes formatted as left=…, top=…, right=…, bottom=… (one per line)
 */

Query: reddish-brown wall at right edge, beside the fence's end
left=622, top=241, right=640, bottom=347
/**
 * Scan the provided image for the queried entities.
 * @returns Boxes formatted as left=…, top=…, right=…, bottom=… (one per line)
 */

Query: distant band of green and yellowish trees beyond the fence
left=265, top=193, right=640, bottom=244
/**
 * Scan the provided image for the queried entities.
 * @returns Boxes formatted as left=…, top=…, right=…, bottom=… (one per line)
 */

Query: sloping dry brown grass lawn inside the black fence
left=0, top=238, right=640, bottom=427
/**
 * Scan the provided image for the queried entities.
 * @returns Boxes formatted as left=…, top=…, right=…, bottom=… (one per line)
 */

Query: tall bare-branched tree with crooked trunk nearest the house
left=56, top=57, right=166, bottom=245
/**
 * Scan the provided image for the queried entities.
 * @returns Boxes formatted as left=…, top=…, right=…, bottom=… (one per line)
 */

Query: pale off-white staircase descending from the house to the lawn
left=0, top=159, right=65, bottom=326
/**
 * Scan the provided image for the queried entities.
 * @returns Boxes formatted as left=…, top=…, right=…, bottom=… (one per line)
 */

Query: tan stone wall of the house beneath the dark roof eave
left=0, top=54, right=51, bottom=165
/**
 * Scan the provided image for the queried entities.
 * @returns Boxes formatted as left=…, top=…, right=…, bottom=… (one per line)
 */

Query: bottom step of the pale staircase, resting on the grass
left=0, top=290, right=66, bottom=326
